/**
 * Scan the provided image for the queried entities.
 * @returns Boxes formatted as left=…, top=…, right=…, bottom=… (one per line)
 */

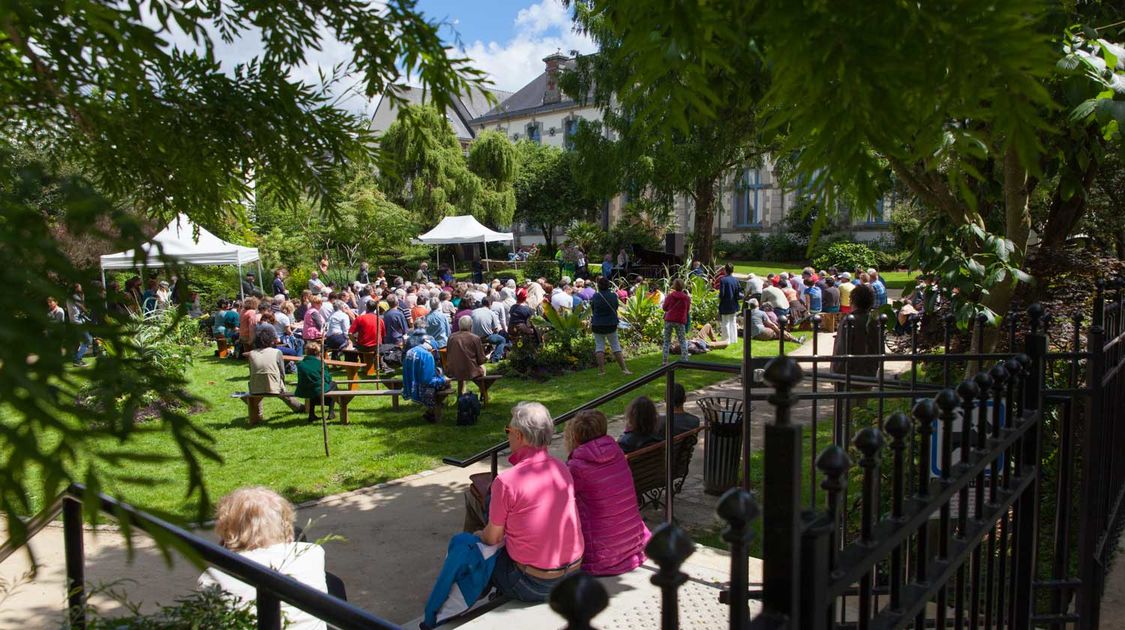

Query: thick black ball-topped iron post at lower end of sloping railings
left=762, top=357, right=802, bottom=628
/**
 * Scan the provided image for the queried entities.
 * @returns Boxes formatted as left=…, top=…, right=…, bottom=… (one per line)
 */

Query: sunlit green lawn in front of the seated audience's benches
left=35, top=341, right=792, bottom=519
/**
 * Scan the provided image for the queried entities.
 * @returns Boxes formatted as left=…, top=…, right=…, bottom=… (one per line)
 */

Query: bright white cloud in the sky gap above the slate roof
left=461, top=0, right=597, bottom=91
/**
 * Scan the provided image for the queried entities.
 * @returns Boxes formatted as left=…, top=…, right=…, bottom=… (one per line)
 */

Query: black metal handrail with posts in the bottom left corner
left=0, top=484, right=401, bottom=630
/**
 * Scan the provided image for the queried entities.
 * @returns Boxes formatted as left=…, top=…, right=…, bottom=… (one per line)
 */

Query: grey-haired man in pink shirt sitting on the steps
left=477, top=403, right=583, bottom=602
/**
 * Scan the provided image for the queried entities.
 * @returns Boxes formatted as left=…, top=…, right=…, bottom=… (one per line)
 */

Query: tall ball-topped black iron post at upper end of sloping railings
left=1011, top=304, right=1047, bottom=628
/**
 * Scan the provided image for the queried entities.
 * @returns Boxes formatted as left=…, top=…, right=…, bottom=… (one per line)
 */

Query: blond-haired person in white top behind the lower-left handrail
left=198, top=486, right=329, bottom=630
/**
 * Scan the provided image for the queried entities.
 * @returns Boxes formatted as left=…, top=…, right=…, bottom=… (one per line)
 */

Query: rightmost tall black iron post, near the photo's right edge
left=1078, top=280, right=1107, bottom=629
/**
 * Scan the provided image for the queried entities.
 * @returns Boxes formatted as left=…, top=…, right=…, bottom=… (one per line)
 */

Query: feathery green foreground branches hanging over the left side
left=0, top=0, right=482, bottom=540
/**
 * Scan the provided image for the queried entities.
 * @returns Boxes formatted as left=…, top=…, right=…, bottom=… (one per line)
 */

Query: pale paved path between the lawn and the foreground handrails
left=0, top=335, right=846, bottom=628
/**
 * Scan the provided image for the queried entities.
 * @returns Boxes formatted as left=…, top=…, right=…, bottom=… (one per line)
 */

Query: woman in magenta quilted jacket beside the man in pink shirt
left=565, top=410, right=651, bottom=575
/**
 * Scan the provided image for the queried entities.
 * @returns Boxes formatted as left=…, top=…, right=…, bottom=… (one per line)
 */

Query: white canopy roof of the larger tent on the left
left=101, top=215, right=259, bottom=269
